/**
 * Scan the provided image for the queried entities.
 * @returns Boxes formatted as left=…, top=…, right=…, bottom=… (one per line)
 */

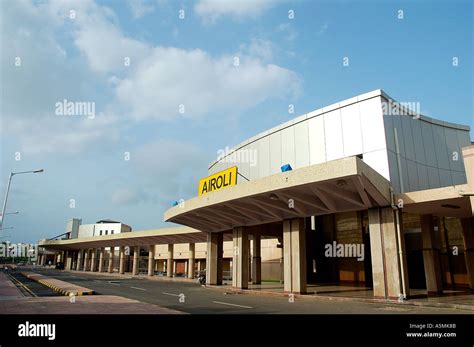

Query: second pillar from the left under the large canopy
left=232, top=227, right=250, bottom=289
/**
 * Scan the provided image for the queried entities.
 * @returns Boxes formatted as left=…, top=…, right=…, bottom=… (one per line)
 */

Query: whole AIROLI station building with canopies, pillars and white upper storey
left=40, top=90, right=474, bottom=299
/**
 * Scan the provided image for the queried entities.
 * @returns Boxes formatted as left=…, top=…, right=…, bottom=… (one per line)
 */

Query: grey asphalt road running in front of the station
left=27, top=269, right=472, bottom=314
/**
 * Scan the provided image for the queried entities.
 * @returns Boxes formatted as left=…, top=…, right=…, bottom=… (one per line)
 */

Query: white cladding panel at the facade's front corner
left=359, top=97, right=387, bottom=152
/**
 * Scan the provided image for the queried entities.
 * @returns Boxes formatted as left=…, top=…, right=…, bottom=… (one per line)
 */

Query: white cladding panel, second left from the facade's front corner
left=341, top=104, right=364, bottom=157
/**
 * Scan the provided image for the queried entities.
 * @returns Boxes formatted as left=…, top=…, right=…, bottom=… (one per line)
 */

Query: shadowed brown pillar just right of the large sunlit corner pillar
left=420, top=214, right=443, bottom=295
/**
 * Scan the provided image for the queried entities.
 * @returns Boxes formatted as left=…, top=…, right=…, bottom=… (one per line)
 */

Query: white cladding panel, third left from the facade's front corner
left=324, top=109, right=344, bottom=161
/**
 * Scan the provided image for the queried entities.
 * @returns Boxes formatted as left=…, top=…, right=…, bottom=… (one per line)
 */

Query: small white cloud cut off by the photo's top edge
left=194, top=0, right=274, bottom=23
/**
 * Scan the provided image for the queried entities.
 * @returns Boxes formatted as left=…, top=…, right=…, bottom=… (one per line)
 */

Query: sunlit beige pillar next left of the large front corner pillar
left=283, top=218, right=306, bottom=294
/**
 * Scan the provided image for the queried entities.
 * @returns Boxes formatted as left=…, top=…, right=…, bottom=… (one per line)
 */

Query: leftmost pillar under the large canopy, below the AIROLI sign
left=206, top=233, right=224, bottom=285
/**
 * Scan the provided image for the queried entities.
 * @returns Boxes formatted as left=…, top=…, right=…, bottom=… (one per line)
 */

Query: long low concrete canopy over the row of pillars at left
left=39, top=227, right=229, bottom=251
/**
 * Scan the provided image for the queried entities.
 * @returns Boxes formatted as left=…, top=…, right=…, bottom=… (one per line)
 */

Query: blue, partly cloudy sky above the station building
left=0, top=0, right=474, bottom=242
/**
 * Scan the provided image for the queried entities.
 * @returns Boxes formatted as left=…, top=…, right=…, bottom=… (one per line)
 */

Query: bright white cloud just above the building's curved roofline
left=117, top=47, right=300, bottom=120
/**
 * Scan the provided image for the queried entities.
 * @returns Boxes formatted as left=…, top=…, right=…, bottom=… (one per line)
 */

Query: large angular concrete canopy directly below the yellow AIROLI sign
left=164, top=157, right=390, bottom=232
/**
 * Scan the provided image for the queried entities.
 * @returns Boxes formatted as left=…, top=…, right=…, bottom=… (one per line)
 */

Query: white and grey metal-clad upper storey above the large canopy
left=209, top=90, right=471, bottom=193
